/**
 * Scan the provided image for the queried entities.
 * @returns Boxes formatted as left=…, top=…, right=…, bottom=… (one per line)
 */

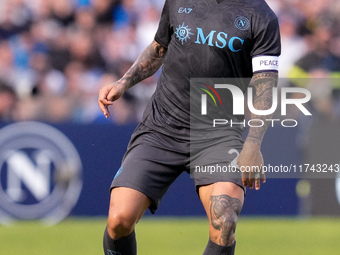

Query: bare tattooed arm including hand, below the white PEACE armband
left=238, top=72, right=278, bottom=190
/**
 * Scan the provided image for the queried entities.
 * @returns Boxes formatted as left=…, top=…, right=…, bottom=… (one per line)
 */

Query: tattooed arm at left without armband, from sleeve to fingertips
left=98, top=41, right=167, bottom=118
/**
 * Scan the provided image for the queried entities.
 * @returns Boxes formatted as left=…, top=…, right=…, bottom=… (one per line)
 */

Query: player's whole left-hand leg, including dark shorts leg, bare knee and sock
left=104, top=125, right=188, bottom=255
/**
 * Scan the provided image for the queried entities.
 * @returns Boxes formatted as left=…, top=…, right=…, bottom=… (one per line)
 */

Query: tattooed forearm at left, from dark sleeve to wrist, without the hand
left=120, top=41, right=167, bottom=89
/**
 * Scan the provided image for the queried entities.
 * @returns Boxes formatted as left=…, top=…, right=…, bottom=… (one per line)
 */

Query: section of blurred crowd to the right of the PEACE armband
left=268, top=0, right=340, bottom=119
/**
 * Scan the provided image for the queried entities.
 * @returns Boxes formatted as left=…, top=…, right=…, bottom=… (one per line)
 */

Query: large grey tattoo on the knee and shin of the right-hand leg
left=210, top=195, right=242, bottom=246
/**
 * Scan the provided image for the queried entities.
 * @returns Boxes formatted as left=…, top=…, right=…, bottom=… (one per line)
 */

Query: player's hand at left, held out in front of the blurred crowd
left=98, top=81, right=124, bottom=118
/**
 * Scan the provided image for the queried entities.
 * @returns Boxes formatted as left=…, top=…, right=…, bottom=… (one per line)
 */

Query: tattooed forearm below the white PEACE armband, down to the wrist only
left=246, top=72, right=278, bottom=144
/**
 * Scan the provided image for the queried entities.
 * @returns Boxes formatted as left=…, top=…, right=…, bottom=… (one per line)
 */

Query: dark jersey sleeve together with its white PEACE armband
left=251, top=18, right=281, bottom=73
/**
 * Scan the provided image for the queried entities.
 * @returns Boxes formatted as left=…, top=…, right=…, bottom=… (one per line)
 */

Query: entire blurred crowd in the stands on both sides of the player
left=0, top=0, right=340, bottom=124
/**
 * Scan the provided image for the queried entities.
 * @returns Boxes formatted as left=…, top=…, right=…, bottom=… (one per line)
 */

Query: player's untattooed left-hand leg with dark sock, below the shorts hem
left=103, top=187, right=151, bottom=255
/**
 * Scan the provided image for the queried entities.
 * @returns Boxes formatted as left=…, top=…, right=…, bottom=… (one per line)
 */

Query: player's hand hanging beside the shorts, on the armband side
left=237, top=142, right=266, bottom=190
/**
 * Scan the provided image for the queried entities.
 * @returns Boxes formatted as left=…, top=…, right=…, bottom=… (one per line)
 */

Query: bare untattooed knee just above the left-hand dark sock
left=107, top=211, right=138, bottom=238
